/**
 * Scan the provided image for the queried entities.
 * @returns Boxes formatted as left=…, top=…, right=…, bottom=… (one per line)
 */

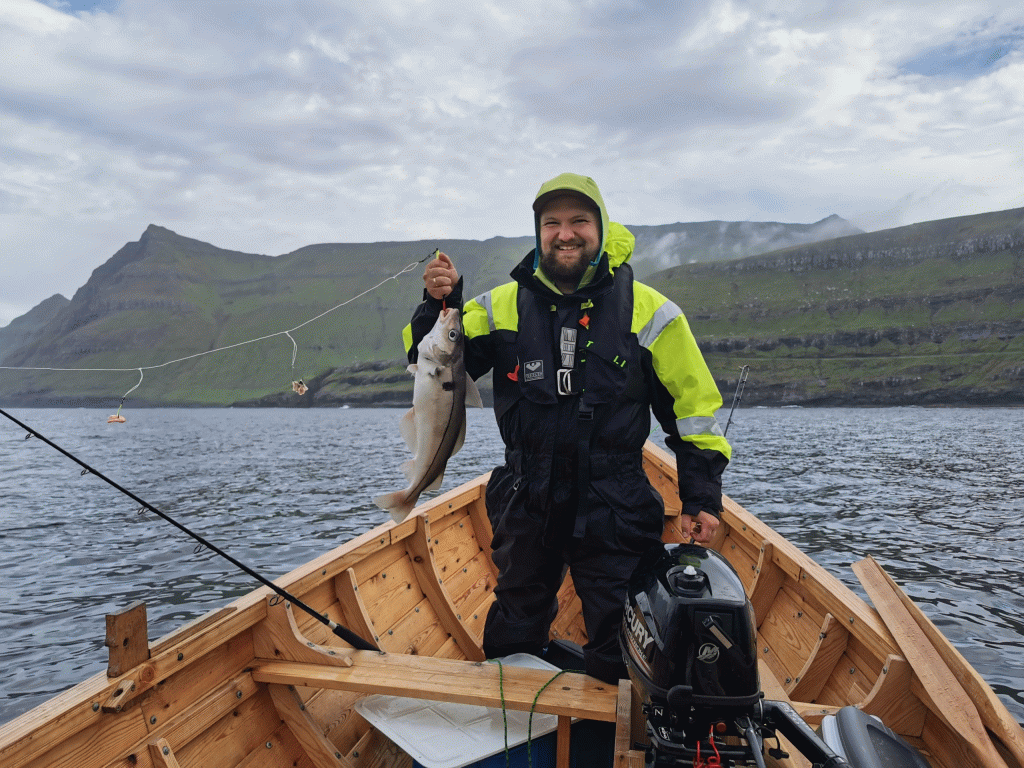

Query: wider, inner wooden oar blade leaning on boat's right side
left=853, top=557, right=1008, bottom=768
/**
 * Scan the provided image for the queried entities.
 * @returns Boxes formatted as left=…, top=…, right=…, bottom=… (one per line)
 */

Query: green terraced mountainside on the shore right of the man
left=648, top=208, right=1024, bottom=406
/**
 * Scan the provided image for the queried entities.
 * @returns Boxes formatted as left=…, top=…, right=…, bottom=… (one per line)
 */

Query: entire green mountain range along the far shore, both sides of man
left=0, top=204, right=1024, bottom=408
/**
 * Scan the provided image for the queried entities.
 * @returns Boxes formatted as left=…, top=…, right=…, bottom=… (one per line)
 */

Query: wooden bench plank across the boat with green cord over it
left=253, top=651, right=616, bottom=722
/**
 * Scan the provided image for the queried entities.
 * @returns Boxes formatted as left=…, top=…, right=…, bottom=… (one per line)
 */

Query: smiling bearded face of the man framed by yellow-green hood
left=540, top=196, right=601, bottom=289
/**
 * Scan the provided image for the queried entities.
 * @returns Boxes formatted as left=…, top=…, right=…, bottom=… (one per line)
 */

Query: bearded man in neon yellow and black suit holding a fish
left=406, top=173, right=730, bottom=682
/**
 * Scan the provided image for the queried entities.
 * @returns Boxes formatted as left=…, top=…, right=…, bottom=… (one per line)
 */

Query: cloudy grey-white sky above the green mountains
left=0, top=0, right=1024, bottom=325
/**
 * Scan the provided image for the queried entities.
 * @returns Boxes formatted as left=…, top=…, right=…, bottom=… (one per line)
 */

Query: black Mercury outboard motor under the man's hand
left=620, top=544, right=849, bottom=768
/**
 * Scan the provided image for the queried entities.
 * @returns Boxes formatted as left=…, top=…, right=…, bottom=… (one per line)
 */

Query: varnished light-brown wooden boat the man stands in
left=0, top=443, right=1024, bottom=768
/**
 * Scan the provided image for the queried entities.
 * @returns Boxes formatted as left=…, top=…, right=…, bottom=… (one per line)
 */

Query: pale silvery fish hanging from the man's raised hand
left=374, top=307, right=483, bottom=522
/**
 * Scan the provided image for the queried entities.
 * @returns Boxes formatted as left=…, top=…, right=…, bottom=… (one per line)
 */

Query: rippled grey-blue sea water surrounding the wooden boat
left=0, top=409, right=1024, bottom=722
